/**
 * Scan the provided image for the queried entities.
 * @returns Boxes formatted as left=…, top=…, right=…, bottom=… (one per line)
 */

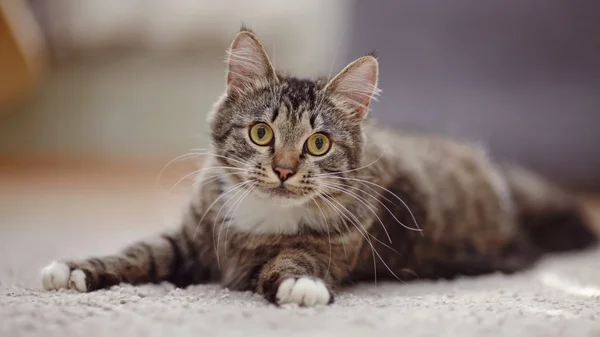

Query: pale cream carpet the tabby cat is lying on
left=0, top=188, right=600, bottom=337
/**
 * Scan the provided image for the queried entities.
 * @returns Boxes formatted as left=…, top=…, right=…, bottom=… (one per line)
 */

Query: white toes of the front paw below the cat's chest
left=276, top=277, right=331, bottom=307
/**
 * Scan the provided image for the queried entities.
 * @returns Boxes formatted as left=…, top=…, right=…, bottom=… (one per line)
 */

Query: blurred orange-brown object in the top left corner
left=0, top=0, right=45, bottom=108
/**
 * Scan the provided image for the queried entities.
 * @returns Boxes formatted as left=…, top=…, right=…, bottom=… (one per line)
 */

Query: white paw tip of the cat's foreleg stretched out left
left=42, top=262, right=87, bottom=292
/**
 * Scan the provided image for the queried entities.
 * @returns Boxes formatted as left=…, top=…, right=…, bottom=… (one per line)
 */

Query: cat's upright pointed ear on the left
left=227, top=28, right=277, bottom=93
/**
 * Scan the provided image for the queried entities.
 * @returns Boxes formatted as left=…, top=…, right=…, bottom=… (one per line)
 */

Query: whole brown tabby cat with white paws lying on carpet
left=42, top=28, right=598, bottom=306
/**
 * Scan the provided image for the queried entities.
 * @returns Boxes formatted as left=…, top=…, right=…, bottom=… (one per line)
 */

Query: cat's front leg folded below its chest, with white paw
left=257, top=249, right=335, bottom=307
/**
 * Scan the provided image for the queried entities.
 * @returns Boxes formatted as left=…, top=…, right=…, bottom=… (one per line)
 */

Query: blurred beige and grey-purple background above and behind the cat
left=0, top=0, right=600, bottom=190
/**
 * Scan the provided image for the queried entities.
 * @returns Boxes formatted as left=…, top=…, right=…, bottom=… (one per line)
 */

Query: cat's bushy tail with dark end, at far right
left=504, top=166, right=600, bottom=252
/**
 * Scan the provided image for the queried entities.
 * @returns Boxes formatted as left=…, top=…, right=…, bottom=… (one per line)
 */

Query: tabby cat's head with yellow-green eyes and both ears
left=209, top=30, right=378, bottom=204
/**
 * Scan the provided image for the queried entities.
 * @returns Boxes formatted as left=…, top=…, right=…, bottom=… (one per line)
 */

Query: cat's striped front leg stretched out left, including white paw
left=42, top=231, right=209, bottom=292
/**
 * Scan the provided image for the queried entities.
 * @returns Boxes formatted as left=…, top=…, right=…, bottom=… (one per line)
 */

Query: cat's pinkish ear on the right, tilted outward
left=325, top=55, right=379, bottom=119
